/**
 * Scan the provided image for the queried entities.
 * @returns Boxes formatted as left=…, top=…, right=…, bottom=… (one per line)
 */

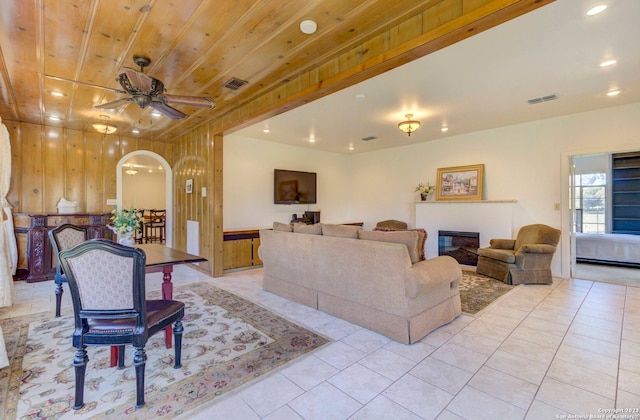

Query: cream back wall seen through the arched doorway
left=122, top=172, right=166, bottom=209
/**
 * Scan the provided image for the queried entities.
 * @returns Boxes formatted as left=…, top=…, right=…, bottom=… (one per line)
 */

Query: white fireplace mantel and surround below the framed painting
left=415, top=200, right=516, bottom=258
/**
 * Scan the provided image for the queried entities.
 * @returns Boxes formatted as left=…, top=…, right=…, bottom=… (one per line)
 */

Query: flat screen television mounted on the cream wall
left=273, top=169, right=317, bottom=204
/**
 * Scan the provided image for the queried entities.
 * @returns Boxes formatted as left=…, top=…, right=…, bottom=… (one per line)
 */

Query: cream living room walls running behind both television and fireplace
left=224, top=103, right=640, bottom=277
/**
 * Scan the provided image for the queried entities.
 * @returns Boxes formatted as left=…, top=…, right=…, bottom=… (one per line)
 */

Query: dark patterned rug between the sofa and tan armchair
left=459, top=270, right=516, bottom=315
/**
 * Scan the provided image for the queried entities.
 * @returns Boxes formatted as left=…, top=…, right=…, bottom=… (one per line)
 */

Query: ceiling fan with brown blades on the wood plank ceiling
left=45, top=55, right=216, bottom=120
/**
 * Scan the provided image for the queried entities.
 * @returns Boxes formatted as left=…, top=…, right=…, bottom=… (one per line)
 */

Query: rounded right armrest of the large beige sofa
left=405, top=255, right=462, bottom=298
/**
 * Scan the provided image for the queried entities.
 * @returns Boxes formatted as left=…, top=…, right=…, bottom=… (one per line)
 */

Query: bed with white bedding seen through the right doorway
left=576, top=233, right=640, bottom=267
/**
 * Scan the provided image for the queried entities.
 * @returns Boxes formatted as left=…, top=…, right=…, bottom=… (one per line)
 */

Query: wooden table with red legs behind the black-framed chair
left=111, top=244, right=207, bottom=367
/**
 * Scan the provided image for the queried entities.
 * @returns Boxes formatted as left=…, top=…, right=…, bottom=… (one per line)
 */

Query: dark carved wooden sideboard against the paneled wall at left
left=13, top=213, right=113, bottom=283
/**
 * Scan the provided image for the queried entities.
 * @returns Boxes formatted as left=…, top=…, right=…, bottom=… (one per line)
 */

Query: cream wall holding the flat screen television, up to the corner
left=223, top=135, right=352, bottom=229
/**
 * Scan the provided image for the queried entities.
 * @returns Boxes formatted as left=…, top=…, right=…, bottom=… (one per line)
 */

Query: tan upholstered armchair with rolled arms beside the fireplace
left=476, top=224, right=560, bottom=284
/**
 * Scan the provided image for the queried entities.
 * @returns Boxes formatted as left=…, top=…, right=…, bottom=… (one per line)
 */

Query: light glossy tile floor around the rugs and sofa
left=0, top=266, right=640, bottom=420
